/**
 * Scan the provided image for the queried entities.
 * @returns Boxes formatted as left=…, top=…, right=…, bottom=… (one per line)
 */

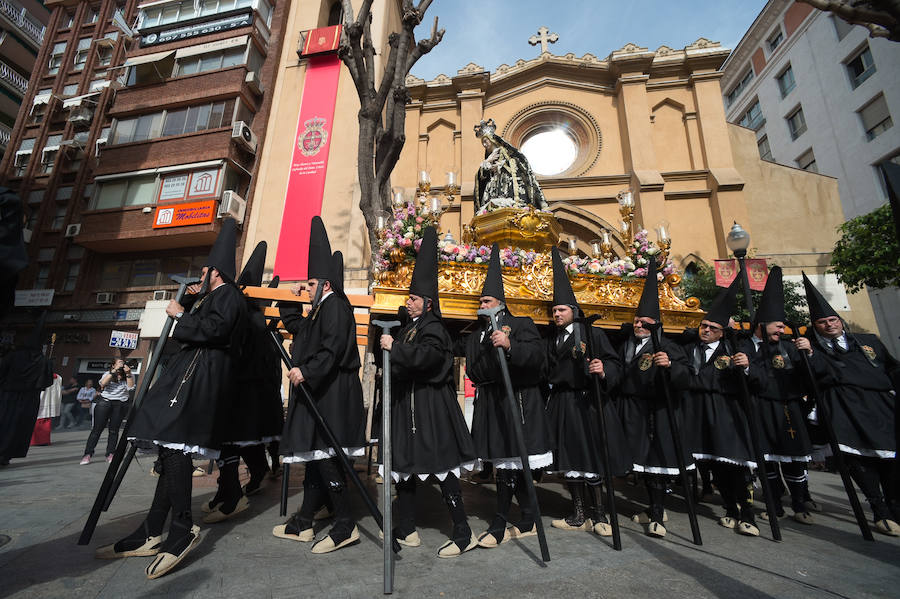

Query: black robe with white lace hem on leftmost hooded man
left=130, top=283, right=247, bottom=458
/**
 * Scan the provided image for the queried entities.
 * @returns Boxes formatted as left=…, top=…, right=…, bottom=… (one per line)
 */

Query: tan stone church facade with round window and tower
left=245, top=3, right=877, bottom=331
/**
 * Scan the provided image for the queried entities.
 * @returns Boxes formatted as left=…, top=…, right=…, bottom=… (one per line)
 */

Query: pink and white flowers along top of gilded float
left=373, top=202, right=675, bottom=277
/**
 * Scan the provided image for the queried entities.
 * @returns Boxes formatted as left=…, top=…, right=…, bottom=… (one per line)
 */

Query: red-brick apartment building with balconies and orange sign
left=0, top=0, right=288, bottom=378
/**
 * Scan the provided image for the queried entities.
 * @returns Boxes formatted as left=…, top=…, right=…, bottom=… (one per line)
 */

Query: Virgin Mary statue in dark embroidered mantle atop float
left=474, top=119, right=548, bottom=214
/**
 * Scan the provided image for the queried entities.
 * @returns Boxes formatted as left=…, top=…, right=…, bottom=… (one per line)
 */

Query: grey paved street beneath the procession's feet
left=0, top=431, right=900, bottom=599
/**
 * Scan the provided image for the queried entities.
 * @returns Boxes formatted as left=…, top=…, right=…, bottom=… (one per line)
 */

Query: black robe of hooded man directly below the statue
left=456, top=311, right=553, bottom=469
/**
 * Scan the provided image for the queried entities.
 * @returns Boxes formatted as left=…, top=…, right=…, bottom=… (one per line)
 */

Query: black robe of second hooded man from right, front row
left=738, top=339, right=824, bottom=462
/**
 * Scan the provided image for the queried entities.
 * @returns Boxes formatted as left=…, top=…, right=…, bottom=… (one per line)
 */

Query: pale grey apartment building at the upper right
left=721, top=0, right=900, bottom=355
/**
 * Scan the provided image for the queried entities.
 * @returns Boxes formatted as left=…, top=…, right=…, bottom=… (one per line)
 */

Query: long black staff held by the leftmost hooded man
left=78, top=275, right=200, bottom=545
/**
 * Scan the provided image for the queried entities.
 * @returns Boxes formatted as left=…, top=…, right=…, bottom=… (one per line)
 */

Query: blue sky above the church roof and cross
left=412, top=0, right=766, bottom=80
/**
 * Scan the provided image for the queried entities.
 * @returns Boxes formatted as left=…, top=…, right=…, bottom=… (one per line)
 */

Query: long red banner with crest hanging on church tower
left=274, top=55, right=341, bottom=281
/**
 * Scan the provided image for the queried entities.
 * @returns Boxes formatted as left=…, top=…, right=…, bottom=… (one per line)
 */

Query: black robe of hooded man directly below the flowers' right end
left=614, top=334, right=694, bottom=474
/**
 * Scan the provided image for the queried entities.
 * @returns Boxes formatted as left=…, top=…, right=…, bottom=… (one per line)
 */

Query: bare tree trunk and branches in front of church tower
left=338, top=0, right=444, bottom=253
